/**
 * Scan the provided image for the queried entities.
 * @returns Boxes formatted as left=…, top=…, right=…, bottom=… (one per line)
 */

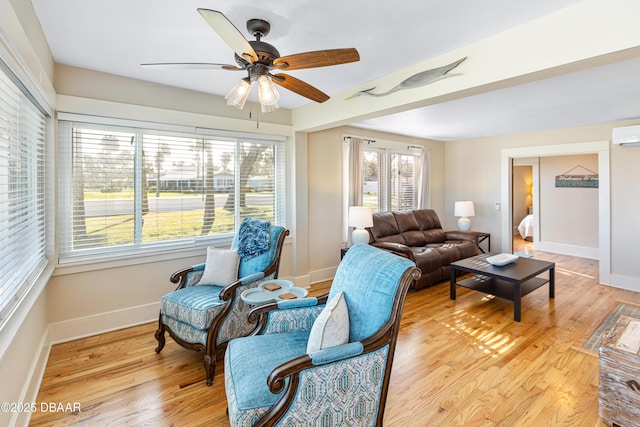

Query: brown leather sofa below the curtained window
left=367, top=209, right=480, bottom=290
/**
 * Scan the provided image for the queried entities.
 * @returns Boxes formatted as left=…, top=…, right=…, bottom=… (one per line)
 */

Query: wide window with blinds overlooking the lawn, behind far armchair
left=59, top=116, right=284, bottom=264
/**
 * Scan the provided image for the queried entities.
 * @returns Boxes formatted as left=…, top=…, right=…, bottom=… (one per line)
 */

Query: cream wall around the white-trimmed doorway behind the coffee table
left=445, top=120, right=640, bottom=291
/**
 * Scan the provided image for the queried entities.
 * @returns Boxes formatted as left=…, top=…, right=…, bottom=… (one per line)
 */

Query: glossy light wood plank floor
left=31, top=252, right=640, bottom=427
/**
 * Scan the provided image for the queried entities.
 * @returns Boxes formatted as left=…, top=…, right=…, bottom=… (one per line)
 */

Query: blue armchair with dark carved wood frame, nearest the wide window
left=155, top=220, right=289, bottom=385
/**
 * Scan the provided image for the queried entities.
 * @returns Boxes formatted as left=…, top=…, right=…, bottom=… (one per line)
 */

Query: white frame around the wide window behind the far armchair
left=56, top=112, right=287, bottom=273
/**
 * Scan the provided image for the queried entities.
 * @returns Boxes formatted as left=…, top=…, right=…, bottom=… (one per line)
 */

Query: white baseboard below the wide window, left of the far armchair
left=49, top=302, right=160, bottom=345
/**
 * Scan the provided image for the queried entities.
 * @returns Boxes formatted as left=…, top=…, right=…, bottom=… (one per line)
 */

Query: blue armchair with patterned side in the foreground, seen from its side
left=225, top=244, right=419, bottom=427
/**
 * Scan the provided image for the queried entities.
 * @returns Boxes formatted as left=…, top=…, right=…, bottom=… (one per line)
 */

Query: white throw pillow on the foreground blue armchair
left=307, top=292, right=349, bottom=353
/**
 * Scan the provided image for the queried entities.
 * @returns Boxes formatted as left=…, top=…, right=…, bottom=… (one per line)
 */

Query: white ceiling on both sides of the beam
left=32, top=0, right=640, bottom=141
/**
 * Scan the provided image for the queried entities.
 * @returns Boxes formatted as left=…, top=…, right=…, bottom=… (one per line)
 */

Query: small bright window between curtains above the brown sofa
left=361, top=148, right=420, bottom=212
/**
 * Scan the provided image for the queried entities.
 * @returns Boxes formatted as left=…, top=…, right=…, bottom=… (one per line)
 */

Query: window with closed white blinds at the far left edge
left=0, top=61, right=47, bottom=324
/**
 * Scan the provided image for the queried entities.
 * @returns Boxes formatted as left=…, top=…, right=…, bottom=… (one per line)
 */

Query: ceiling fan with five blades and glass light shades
left=142, top=9, right=360, bottom=112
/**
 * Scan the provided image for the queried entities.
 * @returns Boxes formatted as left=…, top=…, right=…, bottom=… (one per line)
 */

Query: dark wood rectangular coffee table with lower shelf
left=450, top=253, right=556, bottom=322
